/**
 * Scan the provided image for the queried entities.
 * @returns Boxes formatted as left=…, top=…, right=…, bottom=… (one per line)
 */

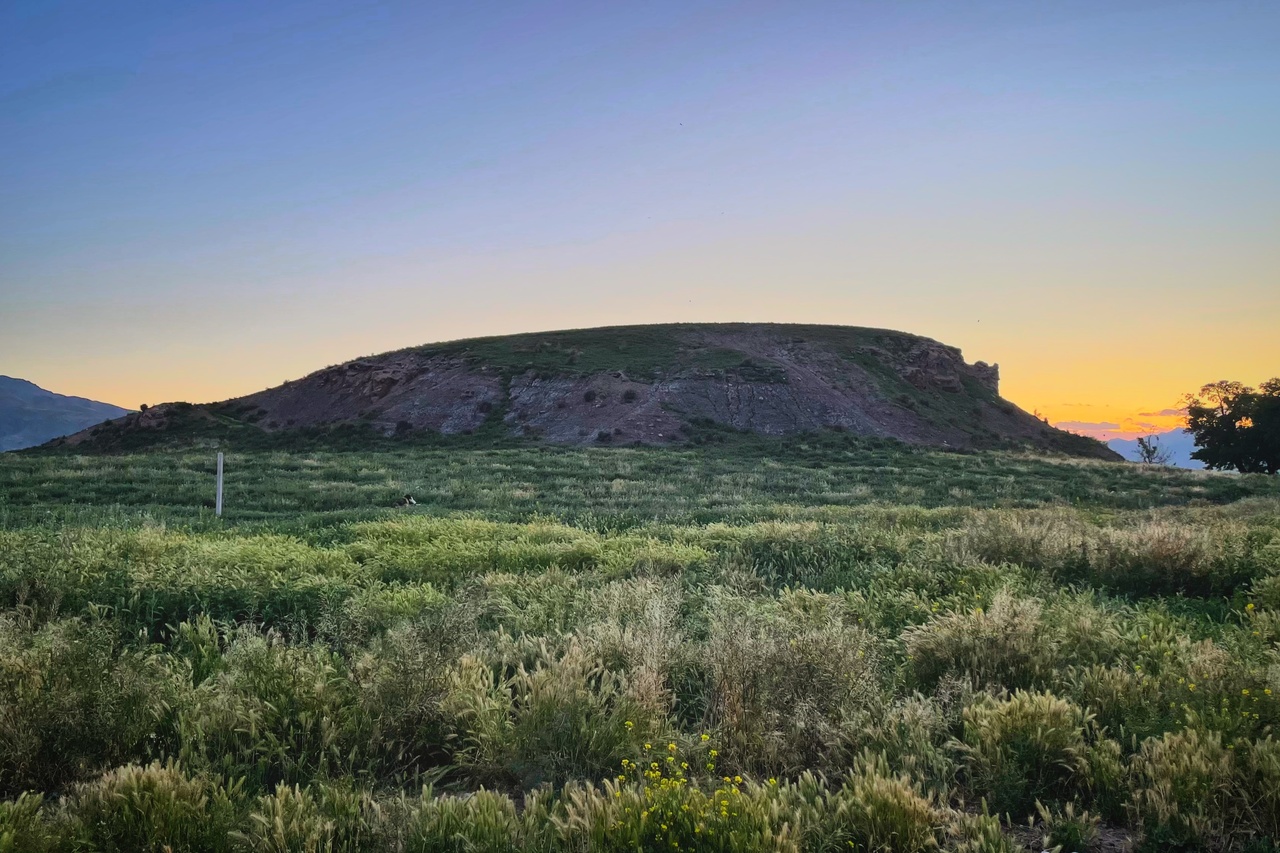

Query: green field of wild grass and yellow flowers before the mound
left=0, top=433, right=1280, bottom=853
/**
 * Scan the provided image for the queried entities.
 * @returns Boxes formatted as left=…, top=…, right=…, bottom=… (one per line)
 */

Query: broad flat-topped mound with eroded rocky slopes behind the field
left=52, top=324, right=1111, bottom=457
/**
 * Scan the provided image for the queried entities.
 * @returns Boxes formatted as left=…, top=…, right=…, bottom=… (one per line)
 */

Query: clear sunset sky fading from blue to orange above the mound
left=0, top=0, right=1280, bottom=438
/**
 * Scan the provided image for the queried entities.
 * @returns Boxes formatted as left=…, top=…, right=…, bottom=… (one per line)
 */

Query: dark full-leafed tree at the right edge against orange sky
left=1187, top=377, right=1280, bottom=474
